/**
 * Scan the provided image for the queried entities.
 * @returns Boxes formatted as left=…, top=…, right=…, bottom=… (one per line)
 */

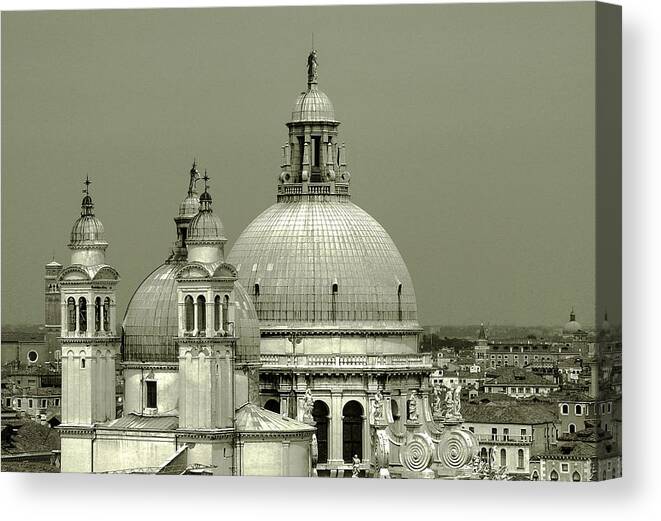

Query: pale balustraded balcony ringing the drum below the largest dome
left=260, top=354, right=432, bottom=370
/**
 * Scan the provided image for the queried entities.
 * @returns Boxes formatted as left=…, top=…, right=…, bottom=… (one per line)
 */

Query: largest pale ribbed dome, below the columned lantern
left=228, top=198, right=419, bottom=332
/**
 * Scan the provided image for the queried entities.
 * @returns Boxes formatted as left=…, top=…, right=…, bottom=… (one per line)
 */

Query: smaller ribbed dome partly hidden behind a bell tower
left=123, top=262, right=259, bottom=362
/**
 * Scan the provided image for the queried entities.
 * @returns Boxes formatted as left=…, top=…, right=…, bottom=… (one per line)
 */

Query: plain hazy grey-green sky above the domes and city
left=2, top=3, right=619, bottom=324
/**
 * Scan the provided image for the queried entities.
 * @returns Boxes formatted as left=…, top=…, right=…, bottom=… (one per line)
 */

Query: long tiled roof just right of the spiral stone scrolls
left=461, top=402, right=557, bottom=425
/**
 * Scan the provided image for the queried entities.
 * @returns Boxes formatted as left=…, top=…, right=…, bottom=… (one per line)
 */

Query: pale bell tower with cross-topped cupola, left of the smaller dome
left=57, top=179, right=120, bottom=472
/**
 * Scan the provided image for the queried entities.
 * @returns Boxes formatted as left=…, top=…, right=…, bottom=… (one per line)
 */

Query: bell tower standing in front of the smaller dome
left=176, top=177, right=238, bottom=429
